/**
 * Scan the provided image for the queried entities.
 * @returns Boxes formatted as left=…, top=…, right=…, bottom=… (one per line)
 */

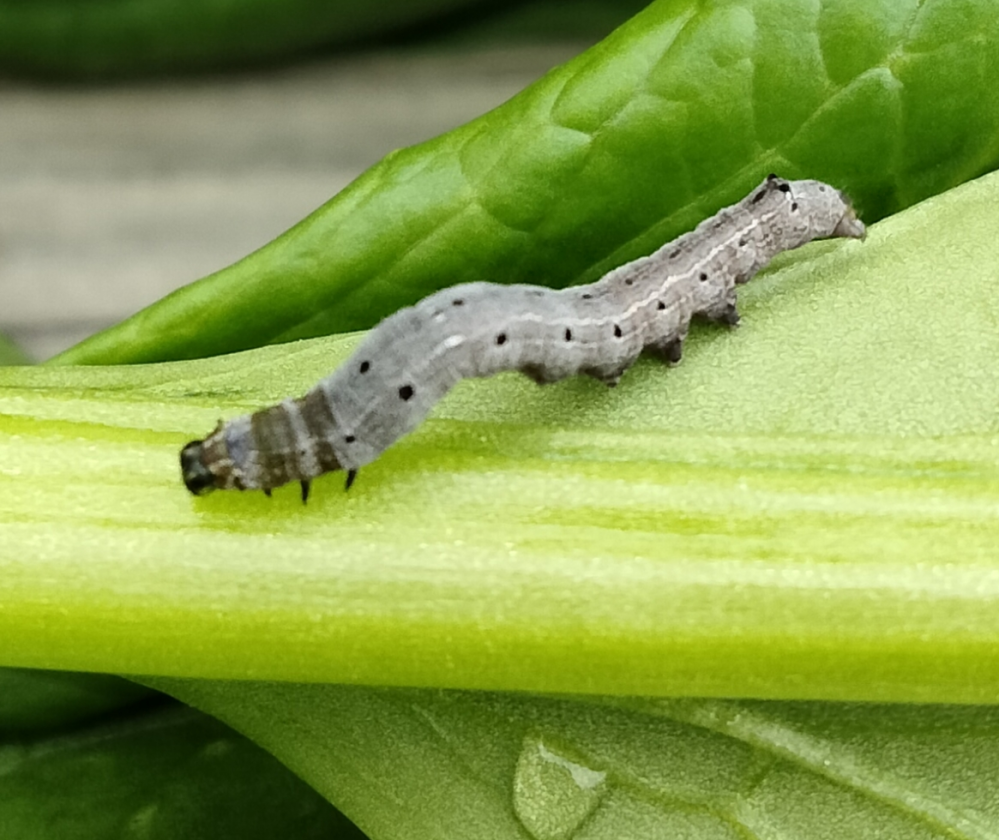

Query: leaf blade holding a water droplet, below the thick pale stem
left=146, top=679, right=999, bottom=840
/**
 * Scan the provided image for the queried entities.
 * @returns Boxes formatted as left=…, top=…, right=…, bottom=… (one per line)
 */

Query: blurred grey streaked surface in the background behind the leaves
left=0, top=43, right=583, bottom=361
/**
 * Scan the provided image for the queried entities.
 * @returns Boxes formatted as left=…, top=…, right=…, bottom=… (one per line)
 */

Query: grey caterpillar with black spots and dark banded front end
left=180, top=175, right=866, bottom=502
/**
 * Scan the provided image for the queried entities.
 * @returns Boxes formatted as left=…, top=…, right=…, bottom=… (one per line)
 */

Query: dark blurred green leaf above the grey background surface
left=0, top=0, right=498, bottom=78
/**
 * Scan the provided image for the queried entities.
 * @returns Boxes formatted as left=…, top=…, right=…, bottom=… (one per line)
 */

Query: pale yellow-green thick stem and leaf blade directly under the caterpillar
left=0, top=171, right=999, bottom=702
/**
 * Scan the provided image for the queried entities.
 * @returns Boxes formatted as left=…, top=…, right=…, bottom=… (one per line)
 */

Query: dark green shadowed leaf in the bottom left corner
left=0, top=700, right=364, bottom=840
